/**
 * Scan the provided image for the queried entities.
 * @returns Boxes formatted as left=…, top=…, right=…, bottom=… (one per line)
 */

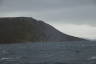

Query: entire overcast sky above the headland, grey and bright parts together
left=0, top=0, right=96, bottom=39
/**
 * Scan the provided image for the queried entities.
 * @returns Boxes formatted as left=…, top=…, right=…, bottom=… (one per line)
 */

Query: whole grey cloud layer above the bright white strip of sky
left=0, top=0, right=96, bottom=24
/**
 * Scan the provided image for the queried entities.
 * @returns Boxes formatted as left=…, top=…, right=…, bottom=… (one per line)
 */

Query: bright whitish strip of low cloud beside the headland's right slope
left=52, top=24, right=96, bottom=40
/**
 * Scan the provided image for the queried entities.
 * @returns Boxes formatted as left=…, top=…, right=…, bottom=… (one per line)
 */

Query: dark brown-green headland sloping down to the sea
left=0, top=17, right=84, bottom=43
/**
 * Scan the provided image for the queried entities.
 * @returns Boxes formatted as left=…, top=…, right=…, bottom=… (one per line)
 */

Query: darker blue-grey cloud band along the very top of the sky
left=0, top=0, right=94, bottom=11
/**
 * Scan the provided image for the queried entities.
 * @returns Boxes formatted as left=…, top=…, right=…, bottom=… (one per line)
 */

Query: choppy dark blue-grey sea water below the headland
left=0, top=42, right=96, bottom=64
